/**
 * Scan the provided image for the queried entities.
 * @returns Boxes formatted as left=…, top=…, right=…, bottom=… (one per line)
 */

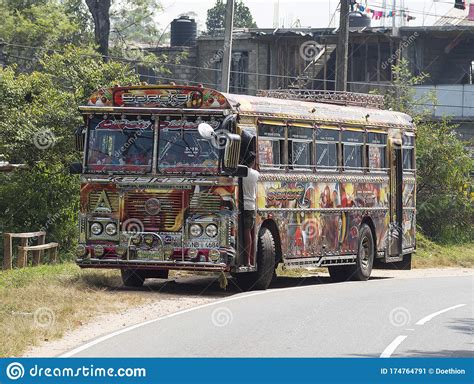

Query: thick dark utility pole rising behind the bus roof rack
left=336, top=0, right=350, bottom=91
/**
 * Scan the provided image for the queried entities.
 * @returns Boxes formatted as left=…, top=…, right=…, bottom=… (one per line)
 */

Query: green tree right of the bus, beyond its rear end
left=385, top=60, right=474, bottom=242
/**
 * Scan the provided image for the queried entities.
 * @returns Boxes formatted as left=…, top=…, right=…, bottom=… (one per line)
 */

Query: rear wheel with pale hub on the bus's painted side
left=349, top=224, right=375, bottom=281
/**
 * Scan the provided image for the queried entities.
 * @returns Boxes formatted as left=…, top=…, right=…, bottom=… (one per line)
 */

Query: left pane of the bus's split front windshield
left=87, top=118, right=153, bottom=173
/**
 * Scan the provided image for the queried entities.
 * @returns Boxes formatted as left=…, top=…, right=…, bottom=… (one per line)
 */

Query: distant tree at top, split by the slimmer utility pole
left=206, top=0, right=257, bottom=35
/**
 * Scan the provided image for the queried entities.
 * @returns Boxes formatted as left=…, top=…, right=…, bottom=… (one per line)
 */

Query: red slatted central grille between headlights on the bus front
left=124, top=190, right=184, bottom=232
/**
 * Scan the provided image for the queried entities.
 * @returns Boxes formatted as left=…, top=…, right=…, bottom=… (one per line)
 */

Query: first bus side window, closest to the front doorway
left=258, top=124, right=285, bottom=169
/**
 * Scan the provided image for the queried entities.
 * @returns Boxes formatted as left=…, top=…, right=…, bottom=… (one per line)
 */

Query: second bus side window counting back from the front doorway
left=288, top=126, right=313, bottom=170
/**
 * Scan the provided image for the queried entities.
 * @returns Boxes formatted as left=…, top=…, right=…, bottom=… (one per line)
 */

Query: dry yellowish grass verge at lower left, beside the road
left=0, top=263, right=145, bottom=357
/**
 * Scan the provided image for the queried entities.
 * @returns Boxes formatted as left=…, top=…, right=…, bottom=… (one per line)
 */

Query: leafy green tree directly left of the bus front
left=0, top=46, right=139, bottom=255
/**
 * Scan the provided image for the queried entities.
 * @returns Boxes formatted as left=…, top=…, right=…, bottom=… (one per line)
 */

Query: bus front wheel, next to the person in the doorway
left=235, top=227, right=275, bottom=291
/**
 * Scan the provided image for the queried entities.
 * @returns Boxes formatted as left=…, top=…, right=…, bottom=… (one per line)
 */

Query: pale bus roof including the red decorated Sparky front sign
left=79, top=84, right=414, bottom=129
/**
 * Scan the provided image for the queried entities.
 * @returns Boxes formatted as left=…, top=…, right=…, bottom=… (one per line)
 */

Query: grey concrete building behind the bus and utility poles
left=144, top=14, right=474, bottom=149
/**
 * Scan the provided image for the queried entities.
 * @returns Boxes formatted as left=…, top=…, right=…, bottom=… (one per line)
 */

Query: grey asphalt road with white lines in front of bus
left=64, top=276, right=474, bottom=357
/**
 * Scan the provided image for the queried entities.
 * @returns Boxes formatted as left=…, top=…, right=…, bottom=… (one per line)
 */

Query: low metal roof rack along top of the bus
left=257, top=89, right=384, bottom=109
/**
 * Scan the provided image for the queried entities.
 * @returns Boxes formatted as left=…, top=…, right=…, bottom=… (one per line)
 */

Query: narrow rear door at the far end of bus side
left=386, top=131, right=403, bottom=261
